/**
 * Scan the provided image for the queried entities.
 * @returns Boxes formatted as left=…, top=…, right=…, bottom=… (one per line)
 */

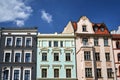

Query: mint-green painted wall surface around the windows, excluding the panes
left=37, top=34, right=76, bottom=80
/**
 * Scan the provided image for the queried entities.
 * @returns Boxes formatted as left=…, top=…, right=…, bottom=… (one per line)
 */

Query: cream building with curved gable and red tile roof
left=63, top=16, right=116, bottom=80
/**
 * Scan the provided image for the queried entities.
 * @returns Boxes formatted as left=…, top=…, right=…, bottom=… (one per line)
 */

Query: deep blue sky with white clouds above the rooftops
left=0, top=0, right=120, bottom=33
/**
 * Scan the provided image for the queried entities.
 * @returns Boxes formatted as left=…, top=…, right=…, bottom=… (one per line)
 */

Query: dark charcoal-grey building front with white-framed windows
left=0, top=28, right=37, bottom=80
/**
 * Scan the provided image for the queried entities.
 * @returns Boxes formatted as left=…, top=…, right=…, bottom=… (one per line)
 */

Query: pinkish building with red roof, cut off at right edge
left=112, top=34, right=120, bottom=80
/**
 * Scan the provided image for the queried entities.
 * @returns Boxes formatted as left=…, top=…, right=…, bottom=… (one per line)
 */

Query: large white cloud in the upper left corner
left=0, top=0, right=32, bottom=26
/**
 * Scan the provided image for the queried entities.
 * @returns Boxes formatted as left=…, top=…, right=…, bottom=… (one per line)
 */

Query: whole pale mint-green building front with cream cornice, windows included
left=37, top=33, right=77, bottom=80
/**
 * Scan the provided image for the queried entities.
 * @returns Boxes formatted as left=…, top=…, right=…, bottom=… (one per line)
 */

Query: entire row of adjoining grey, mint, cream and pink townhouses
left=0, top=16, right=120, bottom=80
